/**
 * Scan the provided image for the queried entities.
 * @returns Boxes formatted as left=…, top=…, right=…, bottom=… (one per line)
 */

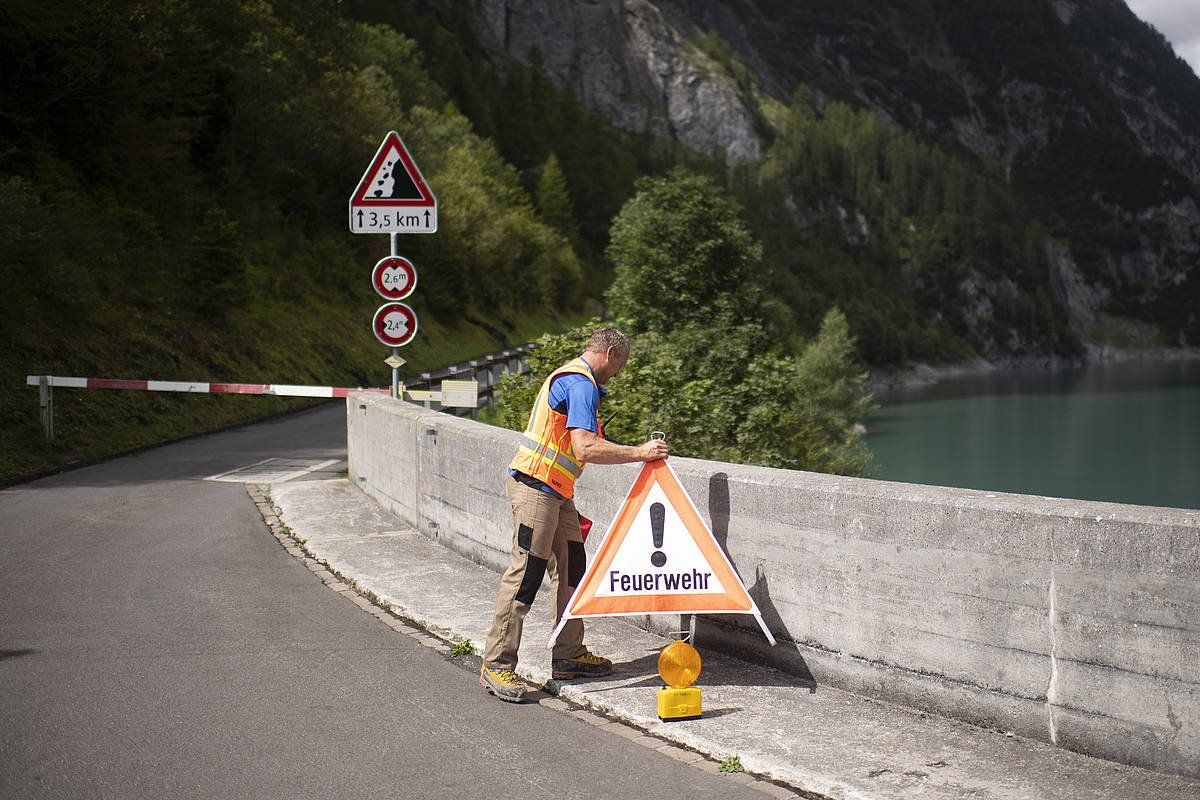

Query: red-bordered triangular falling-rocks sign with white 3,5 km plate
left=350, top=131, right=438, bottom=234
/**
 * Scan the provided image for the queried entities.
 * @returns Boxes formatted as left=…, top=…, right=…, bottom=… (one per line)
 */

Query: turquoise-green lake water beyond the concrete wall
left=866, top=361, right=1200, bottom=509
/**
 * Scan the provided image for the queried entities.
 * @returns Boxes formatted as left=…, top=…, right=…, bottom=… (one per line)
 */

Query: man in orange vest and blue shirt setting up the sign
left=479, top=327, right=667, bottom=703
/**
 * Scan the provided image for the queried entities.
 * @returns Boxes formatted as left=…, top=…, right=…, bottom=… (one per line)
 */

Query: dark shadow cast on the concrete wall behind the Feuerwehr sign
left=696, top=473, right=817, bottom=691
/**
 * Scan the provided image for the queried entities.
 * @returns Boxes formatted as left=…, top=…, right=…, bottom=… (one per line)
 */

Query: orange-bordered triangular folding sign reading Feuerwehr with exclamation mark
left=548, top=459, right=775, bottom=646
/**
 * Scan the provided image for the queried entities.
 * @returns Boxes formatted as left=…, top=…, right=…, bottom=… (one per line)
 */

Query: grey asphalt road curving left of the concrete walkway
left=0, top=404, right=764, bottom=800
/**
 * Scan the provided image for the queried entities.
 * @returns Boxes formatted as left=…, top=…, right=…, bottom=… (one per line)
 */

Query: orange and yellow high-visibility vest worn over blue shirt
left=509, top=357, right=604, bottom=499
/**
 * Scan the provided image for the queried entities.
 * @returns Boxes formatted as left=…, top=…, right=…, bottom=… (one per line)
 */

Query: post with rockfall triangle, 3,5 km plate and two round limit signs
left=349, top=131, right=438, bottom=399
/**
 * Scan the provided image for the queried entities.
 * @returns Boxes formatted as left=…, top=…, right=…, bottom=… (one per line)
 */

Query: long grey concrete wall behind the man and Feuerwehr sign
left=348, top=395, right=1200, bottom=777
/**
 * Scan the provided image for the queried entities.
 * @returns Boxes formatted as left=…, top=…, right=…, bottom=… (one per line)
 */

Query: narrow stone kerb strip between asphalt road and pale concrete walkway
left=244, top=483, right=811, bottom=800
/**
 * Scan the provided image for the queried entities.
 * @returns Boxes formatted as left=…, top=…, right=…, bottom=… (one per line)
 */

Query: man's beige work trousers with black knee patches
left=484, top=475, right=587, bottom=669
